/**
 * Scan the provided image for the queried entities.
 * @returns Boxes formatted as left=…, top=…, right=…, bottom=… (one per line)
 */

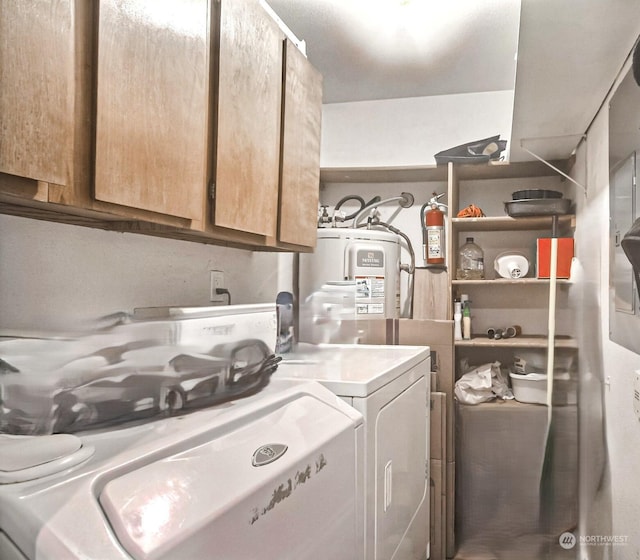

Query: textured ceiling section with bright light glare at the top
left=268, top=0, right=520, bottom=103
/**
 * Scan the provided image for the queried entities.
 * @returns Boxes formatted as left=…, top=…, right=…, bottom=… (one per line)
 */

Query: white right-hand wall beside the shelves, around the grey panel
left=575, top=57, right=640, bottom=560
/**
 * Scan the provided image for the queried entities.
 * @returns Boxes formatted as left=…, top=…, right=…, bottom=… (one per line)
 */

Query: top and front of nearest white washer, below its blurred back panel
left=0, top=379, right=364, bottom=560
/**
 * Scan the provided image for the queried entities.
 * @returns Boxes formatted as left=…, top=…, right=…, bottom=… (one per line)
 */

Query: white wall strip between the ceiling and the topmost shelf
left=320, top=91, right=513, bottom=167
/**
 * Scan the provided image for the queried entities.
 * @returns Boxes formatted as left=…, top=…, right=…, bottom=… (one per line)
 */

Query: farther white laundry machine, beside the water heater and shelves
left=275, top=344, right=430, bottom=560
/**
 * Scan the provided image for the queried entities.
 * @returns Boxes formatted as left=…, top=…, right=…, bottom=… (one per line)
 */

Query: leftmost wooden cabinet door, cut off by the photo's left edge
left=0, top=0, right=75, bottom=185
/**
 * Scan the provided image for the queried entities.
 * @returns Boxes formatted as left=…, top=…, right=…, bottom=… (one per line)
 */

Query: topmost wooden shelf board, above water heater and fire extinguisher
left=320, top=160, right=569, bottom=183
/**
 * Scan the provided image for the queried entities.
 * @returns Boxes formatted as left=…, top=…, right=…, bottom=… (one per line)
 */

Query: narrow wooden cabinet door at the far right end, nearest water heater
left=278, top=40, right=322, bottom=247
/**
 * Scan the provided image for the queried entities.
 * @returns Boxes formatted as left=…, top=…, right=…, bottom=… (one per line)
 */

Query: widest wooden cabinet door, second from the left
left=95, top=0, right=211, bottom=222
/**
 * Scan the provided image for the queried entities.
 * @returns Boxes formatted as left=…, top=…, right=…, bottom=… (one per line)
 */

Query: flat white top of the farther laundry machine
left=277, top=344, right=430, bottom=397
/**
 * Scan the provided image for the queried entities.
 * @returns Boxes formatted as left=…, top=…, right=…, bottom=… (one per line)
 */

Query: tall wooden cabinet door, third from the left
left=213, top=0, right=283, bottom=237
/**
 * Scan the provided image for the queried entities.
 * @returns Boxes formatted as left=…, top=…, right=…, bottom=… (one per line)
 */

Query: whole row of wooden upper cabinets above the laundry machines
left=0, top=0, right=322, bottom=250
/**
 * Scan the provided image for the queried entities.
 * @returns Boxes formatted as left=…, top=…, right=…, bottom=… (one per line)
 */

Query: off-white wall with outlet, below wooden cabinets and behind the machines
left=0, top=215, right=278, bottom=332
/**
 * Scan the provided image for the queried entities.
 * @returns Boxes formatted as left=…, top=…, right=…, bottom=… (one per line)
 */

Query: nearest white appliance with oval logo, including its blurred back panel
left=0, top=305, right=364, bottom=560
